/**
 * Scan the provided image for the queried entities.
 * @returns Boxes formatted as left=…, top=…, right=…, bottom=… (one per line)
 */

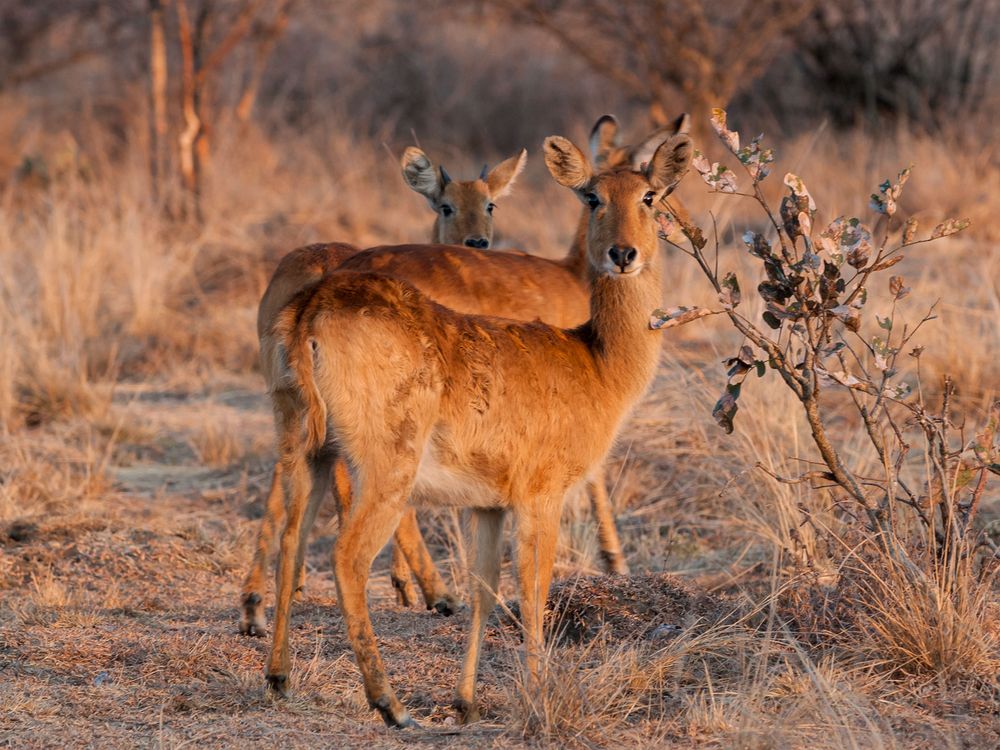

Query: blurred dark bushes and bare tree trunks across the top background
left=0, top=0, right=1000, bottom=197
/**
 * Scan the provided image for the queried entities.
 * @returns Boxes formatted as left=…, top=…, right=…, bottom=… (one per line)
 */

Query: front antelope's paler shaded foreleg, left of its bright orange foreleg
left=455, top=510, right=504, bottom=724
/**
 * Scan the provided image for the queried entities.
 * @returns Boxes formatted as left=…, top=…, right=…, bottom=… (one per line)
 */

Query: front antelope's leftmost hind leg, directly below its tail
left=266, top=444, right=335, bottom=695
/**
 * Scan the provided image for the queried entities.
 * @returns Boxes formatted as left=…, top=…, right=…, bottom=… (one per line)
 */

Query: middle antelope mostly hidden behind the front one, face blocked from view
left=240, top=115, right=690, bottom=635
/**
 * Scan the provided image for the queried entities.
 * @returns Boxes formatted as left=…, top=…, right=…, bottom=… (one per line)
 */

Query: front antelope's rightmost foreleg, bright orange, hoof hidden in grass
left=515, top=497, right=562, bottom=681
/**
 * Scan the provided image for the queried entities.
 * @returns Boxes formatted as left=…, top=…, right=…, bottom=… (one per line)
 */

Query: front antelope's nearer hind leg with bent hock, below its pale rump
left=333, top=468, right=416, bottom=728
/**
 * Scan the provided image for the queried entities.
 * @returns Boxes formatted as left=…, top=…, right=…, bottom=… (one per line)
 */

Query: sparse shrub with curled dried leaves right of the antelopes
left=651, top=109, right=1000, bottom=674
